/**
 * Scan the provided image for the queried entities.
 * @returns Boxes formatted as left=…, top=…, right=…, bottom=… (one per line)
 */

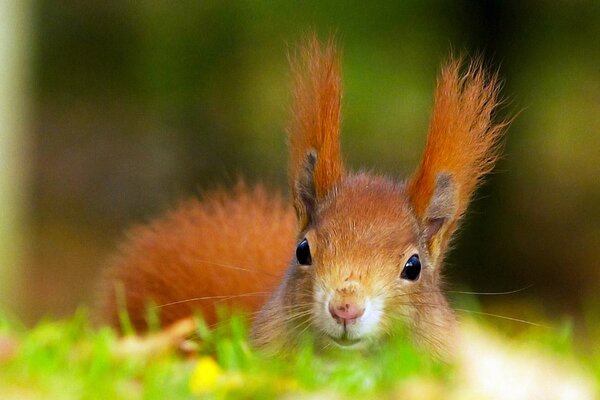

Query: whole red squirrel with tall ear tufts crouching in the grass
left=102, top=36, right=507, bottom=355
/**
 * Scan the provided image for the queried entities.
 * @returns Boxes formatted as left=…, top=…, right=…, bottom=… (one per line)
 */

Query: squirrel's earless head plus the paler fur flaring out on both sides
left=253, top=174, right=455, bottom=357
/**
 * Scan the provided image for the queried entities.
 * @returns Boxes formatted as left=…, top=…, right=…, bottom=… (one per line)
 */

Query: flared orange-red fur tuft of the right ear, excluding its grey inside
left=409, top=60, right=507, bottom=222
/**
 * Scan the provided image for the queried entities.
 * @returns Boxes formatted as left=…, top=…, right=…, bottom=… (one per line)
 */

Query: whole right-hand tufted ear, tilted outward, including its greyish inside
left=408, top=60, right=508, bottom=263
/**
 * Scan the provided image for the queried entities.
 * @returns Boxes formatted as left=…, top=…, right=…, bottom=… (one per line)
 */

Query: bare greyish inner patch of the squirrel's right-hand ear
left=424, top=172, right=457, bottom=241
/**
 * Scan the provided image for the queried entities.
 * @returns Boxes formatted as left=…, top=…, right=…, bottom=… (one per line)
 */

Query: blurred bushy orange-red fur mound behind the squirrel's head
left=103, top=185, right=296, bottom=330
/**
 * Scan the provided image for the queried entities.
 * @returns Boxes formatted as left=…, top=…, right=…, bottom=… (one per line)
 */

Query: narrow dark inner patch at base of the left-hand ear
left=294, top=150, right=317, bottom=231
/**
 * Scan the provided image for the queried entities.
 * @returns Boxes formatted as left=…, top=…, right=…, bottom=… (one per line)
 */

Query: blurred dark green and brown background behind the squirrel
left=0, top=0, right=600, bottom=323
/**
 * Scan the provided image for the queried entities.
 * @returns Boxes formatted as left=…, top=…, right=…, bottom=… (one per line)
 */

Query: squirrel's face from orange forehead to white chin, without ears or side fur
left=290, top=174, right=451, bottom=348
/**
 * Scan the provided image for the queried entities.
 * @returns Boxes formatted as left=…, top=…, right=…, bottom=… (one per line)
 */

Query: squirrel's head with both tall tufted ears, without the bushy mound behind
left=255, top=36, right=506, bottom=360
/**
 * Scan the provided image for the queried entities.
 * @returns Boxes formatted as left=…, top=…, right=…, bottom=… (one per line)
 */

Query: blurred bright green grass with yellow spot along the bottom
left=0, top=311, right=600, bottom=399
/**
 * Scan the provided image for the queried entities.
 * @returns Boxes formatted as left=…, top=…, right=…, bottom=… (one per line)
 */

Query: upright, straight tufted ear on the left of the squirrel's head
left=288, top=35, right=344, bottom=231
